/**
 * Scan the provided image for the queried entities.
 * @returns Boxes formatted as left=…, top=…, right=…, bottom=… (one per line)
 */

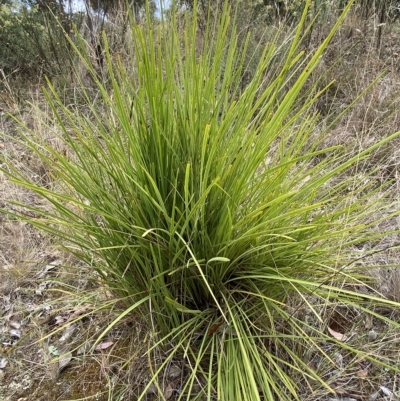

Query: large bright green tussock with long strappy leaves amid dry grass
left=3, top=2, right=398, bottom=401
